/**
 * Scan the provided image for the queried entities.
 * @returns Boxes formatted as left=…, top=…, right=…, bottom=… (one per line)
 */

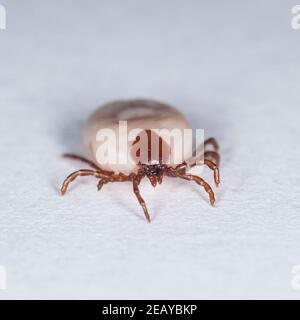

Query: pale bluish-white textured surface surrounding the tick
left=0, top=0, right=300, bottom=299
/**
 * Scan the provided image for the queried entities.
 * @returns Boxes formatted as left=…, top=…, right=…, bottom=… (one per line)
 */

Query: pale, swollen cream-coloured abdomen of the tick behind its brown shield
left=84, top=100, right=193, bottom=174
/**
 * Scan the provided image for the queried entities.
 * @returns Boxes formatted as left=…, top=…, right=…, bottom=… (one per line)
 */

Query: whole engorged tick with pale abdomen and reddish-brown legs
left=61, top=100, right=220, bottom=222
